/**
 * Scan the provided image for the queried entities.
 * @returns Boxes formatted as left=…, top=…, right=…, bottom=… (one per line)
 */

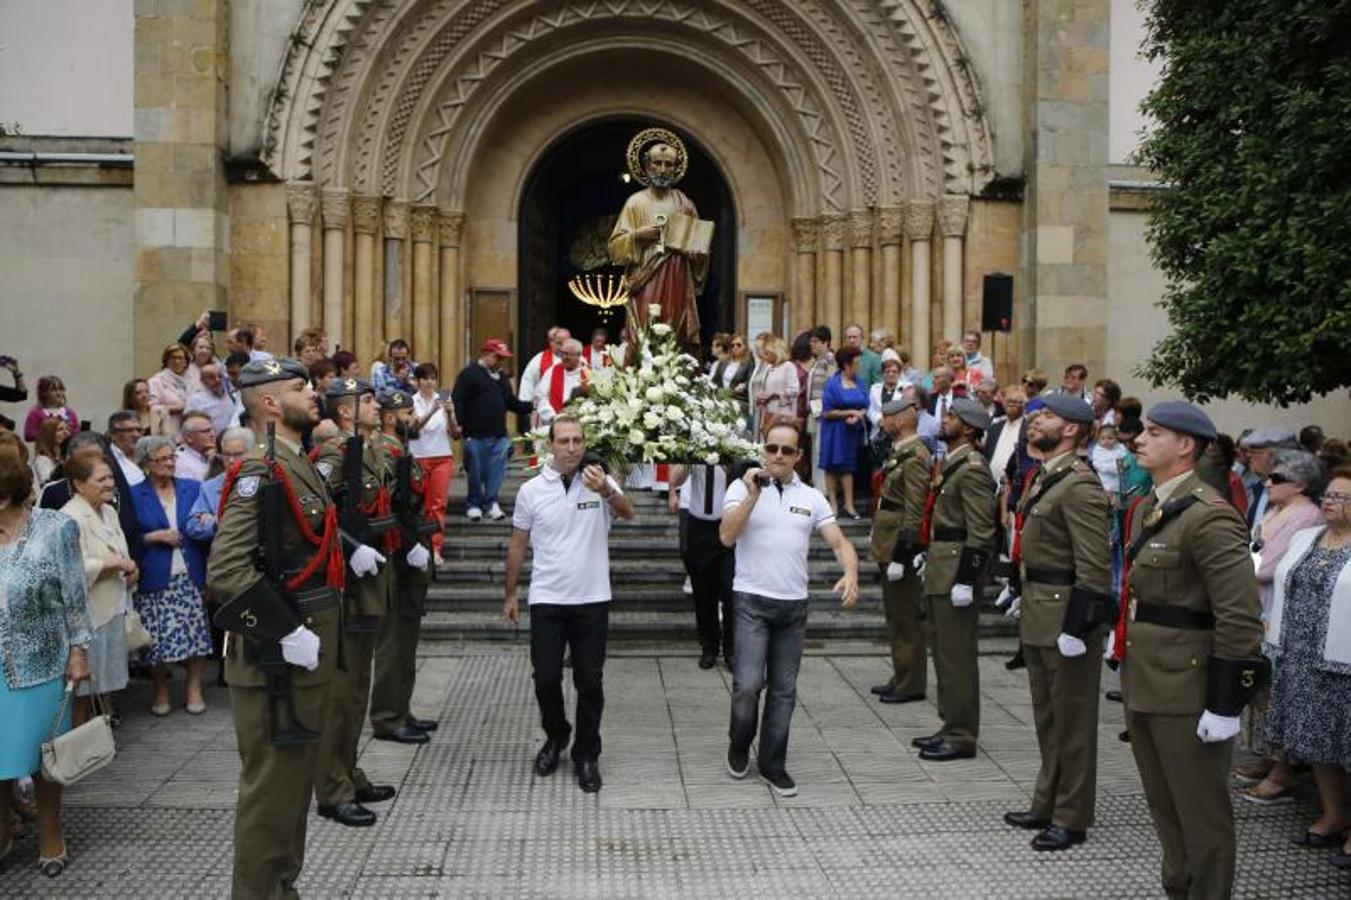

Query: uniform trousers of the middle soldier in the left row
left=315, top=627, right=388, bottom=807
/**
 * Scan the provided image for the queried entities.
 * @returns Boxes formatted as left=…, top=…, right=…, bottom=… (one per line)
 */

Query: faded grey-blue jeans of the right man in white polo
left=728, top=591, right=808, bottom=776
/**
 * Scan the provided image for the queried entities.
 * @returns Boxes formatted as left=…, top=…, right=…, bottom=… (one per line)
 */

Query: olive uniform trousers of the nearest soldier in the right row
left=1125, top=712, right=1235, bottom=900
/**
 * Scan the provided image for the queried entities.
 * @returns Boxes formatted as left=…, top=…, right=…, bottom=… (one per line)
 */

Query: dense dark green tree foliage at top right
left=1140, top=0, right=1351, bottom=405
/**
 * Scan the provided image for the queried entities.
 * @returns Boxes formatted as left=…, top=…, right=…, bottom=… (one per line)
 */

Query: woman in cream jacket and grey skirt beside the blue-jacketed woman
left=61, top=453, right=139, bottom=724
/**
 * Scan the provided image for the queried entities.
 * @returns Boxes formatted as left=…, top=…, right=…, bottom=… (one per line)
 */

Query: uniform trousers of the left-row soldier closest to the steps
left=370, top=565, right=427, bottom=734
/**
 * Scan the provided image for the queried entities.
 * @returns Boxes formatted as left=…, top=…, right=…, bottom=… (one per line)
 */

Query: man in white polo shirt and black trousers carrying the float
left=503, top=416, right=634, bottom=793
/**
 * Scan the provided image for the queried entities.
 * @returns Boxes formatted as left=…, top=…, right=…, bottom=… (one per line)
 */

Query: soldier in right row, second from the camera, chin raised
left=1004, top=393, right=1116, bottom=850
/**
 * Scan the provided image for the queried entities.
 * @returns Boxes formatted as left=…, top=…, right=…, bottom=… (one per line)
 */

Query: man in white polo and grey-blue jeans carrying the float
left=719, top=424, right=858, bottom=797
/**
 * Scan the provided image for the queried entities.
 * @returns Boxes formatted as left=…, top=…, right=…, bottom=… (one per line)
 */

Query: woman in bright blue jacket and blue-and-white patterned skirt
left=131, top=438, right=211, bottom=716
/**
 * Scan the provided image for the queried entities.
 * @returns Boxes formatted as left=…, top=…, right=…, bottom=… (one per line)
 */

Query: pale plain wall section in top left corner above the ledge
left=0, top=0, right=134, bottom=138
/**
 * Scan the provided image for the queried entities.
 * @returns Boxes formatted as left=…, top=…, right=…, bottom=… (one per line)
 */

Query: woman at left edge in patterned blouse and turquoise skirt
left=0, top=431, right=91, bottom=878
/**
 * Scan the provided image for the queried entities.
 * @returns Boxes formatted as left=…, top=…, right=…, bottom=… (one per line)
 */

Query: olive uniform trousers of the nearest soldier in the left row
left=230, top=684, right=332, bottom=900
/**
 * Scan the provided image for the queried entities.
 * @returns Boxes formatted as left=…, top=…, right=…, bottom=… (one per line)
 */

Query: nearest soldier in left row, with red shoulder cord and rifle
left=207, top=359, right=343, bottom=897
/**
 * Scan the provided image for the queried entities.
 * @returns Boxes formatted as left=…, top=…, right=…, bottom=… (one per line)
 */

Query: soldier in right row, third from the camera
left=912, top=397, right=994, bottom=762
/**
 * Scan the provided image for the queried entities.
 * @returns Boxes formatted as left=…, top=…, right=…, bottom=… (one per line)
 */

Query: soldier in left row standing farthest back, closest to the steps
left=370, top=391, right=436, bottom=743
